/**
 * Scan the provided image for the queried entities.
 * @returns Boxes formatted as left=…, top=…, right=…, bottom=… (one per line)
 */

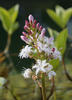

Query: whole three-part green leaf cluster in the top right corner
left=47, top=6, right=72, bottom=28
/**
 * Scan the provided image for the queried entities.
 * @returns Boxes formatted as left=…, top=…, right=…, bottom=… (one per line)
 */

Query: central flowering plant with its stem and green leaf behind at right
left=19, top=14, right=67, bottom=100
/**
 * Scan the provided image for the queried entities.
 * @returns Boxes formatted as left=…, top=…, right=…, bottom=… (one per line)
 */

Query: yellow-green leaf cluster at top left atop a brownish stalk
left=0, top=4, right=19, bottom=35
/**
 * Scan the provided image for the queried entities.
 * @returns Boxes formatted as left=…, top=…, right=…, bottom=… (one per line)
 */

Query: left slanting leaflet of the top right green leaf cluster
left=47, top=9, right=64, bottom=28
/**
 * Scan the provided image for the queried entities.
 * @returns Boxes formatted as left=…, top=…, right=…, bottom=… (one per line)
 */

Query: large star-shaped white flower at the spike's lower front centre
left=32, top=59, right=53, bottom=75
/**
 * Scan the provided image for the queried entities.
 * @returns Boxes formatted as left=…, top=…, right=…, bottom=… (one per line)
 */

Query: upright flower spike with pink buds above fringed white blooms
left=19, top=15, right=61, bottom=79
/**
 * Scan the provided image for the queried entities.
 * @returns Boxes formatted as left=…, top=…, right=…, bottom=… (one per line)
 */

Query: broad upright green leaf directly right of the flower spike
left=55, top=29, right=68, bottom=54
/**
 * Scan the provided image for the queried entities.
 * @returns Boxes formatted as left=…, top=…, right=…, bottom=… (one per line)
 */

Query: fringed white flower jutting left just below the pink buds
left=19, top=45, right=32, bottom=59
